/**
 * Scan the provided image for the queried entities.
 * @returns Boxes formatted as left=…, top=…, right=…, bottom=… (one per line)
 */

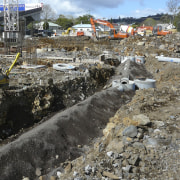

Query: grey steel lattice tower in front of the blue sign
left=3, top=0, right=20, bottom=54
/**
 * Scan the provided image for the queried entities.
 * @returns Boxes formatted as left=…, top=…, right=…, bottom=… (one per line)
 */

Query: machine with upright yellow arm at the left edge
left=0, top=53, right=20, bottom=87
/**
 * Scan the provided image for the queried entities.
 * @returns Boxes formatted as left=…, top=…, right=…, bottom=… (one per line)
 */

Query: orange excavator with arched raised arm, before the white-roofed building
left=90, top=18, right=129, bottom=39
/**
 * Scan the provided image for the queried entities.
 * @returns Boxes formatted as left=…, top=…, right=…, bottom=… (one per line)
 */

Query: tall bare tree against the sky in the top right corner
left=167, top=0, right=180, bottom=21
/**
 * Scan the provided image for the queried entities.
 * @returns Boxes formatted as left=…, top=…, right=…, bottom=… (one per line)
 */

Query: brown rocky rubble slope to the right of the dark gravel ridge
left=40, top=34, right=180, bottom=180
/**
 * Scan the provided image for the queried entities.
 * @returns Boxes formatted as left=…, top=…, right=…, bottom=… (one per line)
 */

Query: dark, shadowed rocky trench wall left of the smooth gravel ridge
left=0, top=67, right=114, bottom=139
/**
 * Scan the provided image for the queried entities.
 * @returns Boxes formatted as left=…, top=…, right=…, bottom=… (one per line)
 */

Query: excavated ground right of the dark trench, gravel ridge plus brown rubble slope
left=0, top=34, right=180, bottom=180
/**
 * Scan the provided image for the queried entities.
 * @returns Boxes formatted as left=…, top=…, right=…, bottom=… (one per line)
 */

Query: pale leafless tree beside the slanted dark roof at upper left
left=41, top=4, right=56, bottom=20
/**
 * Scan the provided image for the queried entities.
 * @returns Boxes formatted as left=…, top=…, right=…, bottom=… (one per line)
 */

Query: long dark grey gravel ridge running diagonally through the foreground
left=0, top=88, right=134, bottom=180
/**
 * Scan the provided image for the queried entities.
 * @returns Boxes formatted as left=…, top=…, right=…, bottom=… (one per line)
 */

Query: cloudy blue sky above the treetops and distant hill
left=19, top=0, right=168, bottom=19
